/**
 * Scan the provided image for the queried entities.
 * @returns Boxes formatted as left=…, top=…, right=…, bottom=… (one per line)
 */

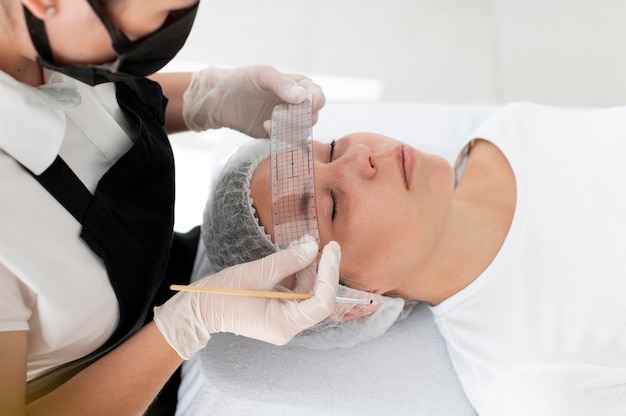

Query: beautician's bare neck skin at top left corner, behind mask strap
left=0, top=2, right=43, bottom=86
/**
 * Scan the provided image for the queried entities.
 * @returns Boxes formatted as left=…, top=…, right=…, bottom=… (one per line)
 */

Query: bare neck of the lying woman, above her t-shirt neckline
left=413, top=140, right=517, bottom=305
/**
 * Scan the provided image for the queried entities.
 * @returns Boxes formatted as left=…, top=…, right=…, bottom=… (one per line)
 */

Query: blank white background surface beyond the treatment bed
left=166, top=0, right=626, bottom=106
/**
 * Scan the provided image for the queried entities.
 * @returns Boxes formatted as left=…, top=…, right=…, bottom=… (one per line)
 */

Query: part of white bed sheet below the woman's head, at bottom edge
left=177, top=304, right=475, bottom=416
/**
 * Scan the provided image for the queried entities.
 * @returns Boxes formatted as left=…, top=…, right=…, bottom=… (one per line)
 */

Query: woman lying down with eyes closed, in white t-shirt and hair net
left=203, top=104, right=626, bottom=415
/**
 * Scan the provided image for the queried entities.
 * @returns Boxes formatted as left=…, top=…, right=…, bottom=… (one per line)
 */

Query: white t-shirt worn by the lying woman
left=432, top=103, right=626, bottom=416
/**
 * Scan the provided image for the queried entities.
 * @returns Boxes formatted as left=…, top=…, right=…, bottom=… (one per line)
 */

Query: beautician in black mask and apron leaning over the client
left=0, top=0, right=340, bottom=415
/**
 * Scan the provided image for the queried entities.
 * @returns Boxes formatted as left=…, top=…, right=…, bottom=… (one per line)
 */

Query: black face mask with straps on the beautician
left=24, top=0, right=198, bottom=85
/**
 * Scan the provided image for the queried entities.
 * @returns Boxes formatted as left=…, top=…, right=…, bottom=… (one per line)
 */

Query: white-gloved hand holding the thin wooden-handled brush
left=154, top=241, right=341, bottom=359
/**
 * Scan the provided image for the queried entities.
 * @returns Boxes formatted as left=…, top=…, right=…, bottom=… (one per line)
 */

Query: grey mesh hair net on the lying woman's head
left=201, top=140, right=413, bottom=349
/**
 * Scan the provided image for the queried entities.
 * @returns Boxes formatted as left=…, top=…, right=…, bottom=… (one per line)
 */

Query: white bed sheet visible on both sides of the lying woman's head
left=177, top=104, right=494, bottom=416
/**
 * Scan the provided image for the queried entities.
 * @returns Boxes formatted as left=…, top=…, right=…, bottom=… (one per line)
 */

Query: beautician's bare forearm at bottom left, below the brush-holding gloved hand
left=27, top=322, right=183, bottom=415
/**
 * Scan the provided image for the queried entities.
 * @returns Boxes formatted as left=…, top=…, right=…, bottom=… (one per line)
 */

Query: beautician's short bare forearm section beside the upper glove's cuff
left=150, top=72, right=191, bottom=133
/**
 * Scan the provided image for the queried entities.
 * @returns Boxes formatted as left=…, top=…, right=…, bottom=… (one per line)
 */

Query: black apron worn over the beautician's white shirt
left=26, top=79, right=197, bottom=403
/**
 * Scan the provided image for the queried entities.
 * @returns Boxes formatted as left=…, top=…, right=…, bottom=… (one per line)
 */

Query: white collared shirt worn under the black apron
left=0, top=72, right=132, bottom=380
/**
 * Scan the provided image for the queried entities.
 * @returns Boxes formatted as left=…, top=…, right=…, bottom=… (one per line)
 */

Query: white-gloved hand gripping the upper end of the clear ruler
left=183, top=65, right=326, bottom=138
